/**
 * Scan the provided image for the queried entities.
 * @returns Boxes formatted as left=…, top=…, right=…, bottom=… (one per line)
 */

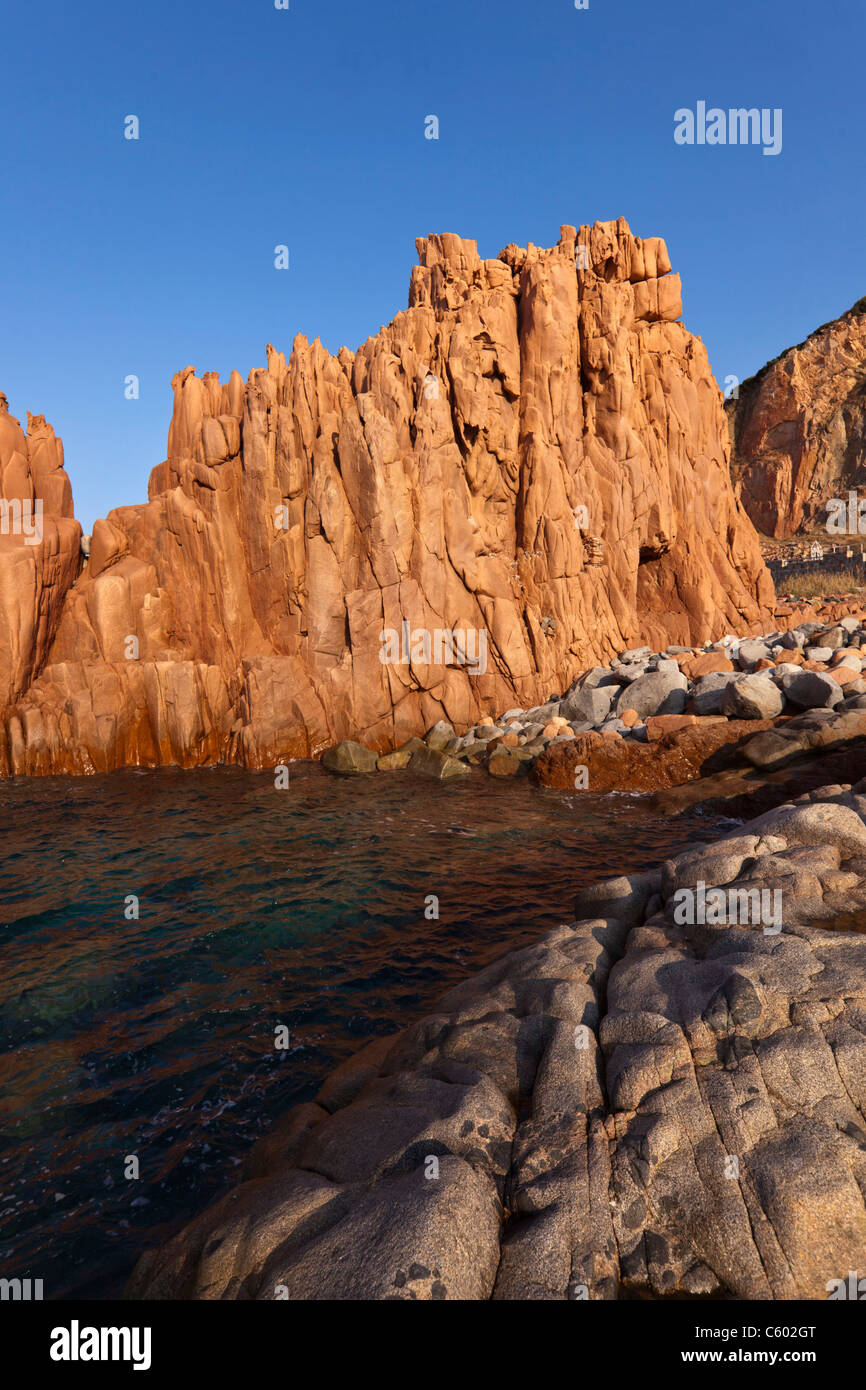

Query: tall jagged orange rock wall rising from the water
left=0, top=220, right=773, bottom=773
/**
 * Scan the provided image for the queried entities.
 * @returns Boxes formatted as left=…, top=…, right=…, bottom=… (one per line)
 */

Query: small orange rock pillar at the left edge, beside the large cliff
left=0, top=395, right=82, bottom=710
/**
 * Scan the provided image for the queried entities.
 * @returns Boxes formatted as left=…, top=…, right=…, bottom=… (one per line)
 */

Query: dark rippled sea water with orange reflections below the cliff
left=0, top=763, right=713, bottom=1298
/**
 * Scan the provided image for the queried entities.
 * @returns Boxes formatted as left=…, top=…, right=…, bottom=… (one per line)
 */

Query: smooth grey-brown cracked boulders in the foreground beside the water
left=128, top=784, right=866, bottom=1300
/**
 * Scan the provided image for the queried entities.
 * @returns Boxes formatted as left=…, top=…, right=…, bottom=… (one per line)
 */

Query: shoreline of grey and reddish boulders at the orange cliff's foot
left=321, top=609, right=866, bottom=795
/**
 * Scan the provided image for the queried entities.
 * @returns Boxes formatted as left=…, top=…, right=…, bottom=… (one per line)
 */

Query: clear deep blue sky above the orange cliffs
left=0, top=0, right=866, bottom=530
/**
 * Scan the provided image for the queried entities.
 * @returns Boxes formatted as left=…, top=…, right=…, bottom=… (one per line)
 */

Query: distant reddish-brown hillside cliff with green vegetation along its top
left=726, top=300, right=866, bottom=538
